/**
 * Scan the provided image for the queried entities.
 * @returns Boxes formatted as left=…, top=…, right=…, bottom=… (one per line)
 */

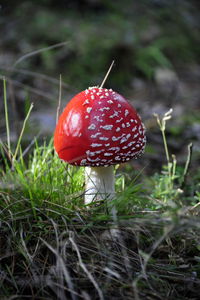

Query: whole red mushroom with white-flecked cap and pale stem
left=54, top=87, right=146, bottom=204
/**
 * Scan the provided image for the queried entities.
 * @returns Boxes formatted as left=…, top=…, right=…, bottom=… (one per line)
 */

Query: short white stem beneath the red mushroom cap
left=85, top=166, right=115, bottom=204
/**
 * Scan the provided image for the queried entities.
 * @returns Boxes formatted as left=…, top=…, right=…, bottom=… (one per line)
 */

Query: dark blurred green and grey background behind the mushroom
left=0, top=0, right=200, bottom=173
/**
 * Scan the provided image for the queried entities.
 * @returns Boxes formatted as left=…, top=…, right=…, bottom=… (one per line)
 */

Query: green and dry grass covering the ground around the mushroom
left=0, top=81, right=200, bottom=299
